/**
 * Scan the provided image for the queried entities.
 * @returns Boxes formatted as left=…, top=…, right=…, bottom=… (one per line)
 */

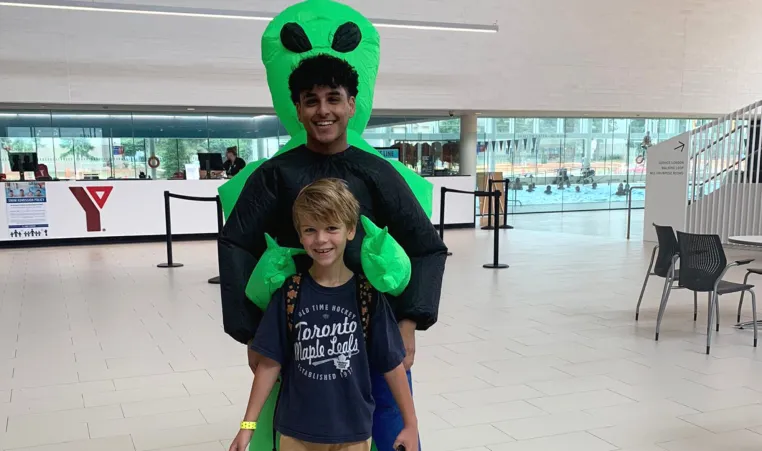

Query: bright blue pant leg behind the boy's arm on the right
left=370, top=371, right=421, bottom=451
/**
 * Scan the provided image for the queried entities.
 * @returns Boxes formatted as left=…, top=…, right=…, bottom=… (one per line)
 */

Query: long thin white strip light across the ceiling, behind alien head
left=0, top=0, right=498, bottom=33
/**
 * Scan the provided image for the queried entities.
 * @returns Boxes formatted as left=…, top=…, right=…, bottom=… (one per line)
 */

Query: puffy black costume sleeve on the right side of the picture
left=373, top=157, right=447, bottom=330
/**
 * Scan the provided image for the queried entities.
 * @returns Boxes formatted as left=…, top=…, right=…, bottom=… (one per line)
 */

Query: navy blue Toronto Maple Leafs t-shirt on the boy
left=251, top=274, right=405, bottom=444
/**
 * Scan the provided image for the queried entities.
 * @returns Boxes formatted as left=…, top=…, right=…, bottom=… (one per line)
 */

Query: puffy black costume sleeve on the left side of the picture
left=217, top=164, right=277, bottom=344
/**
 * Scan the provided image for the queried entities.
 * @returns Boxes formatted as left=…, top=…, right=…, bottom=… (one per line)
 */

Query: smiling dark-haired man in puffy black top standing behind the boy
left=218, top=55, right=447, bottom=451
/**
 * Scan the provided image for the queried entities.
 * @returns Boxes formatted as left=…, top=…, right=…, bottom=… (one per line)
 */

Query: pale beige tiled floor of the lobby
left=0, top=212, right=762, bottom=451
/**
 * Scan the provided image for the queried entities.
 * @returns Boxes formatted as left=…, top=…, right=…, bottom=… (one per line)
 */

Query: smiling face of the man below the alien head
left=296, top=86, right=355, bottom=144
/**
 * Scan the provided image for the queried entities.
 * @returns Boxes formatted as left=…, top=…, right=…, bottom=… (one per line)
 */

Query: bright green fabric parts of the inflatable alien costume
left=218, top=0, right=433, bottom=451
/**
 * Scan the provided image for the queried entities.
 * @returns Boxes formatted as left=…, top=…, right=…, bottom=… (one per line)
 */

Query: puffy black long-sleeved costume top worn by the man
left=218, top=146, right=447, bottom=343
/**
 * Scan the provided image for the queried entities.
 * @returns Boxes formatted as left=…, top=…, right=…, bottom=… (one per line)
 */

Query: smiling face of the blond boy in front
left=299, top=217, right=355, bottom=267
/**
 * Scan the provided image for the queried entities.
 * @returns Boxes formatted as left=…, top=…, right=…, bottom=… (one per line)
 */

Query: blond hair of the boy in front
left=292, top=178, right=360, bottom=234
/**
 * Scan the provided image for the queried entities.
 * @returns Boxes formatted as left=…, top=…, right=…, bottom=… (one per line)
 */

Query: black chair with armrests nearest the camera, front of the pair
left=656, top=232, right=757, bottom=354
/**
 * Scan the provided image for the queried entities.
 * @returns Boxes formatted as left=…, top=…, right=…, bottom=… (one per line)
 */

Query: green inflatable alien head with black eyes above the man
left=262, top=0, right=381, bottom=137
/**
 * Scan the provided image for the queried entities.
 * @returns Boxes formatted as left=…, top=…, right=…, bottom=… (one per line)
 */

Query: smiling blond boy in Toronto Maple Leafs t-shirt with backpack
left=230, top=179, right=418, bottom=451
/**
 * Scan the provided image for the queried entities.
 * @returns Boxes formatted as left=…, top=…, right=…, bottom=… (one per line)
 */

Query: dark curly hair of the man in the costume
left=288, top=54, right=360, bottom=104
